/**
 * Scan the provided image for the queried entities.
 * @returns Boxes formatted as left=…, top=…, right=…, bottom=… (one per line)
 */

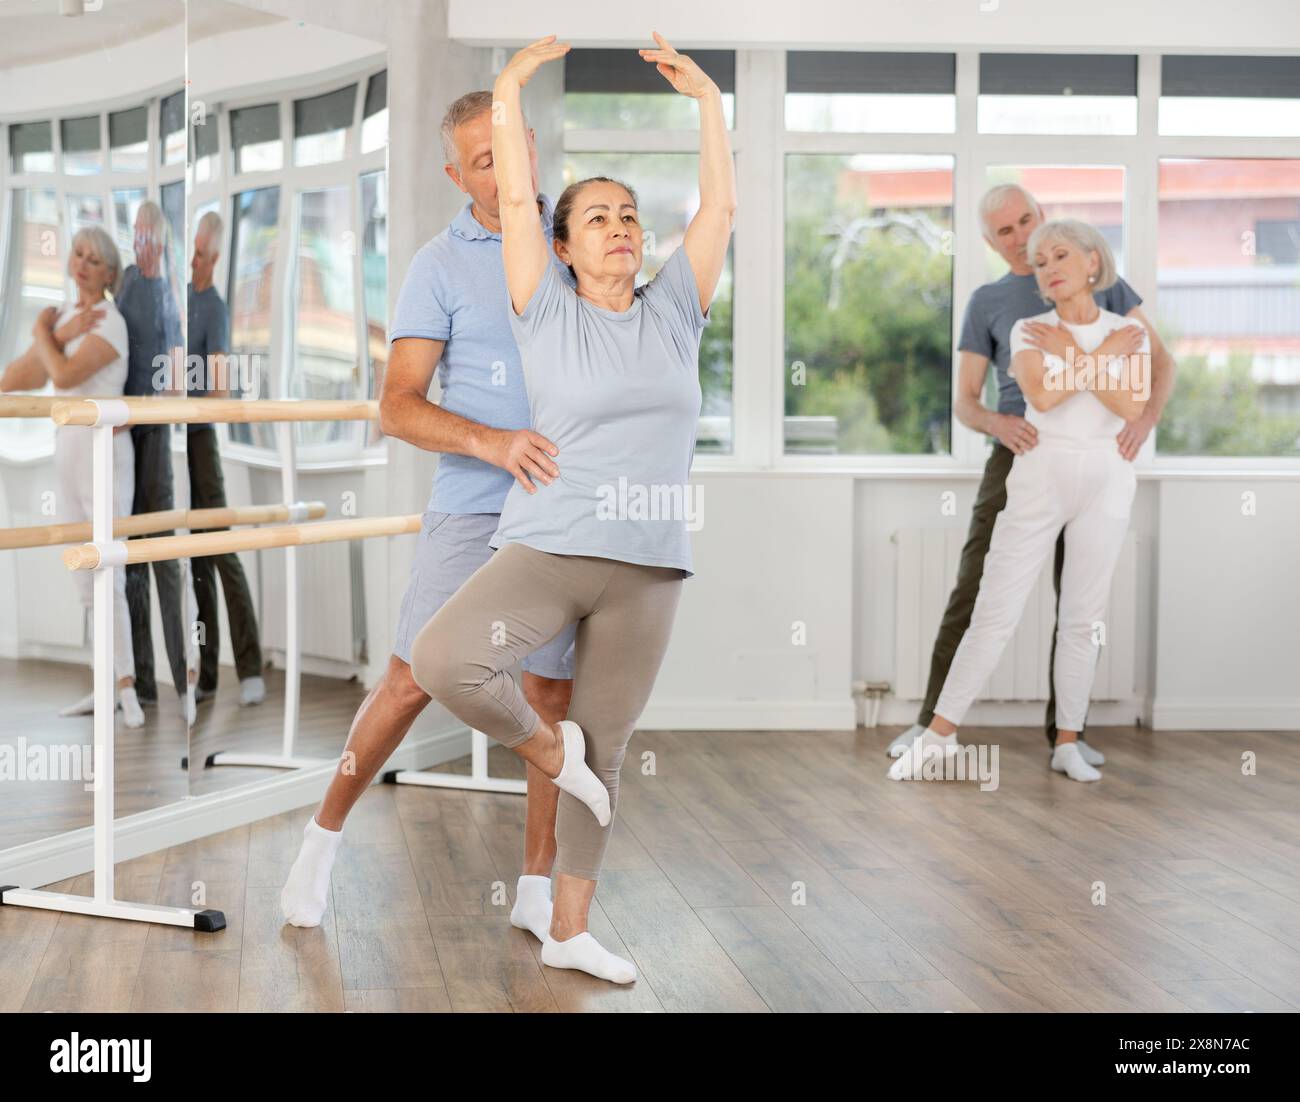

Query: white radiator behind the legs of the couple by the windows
left=893, top=528, right=1138, bottom=700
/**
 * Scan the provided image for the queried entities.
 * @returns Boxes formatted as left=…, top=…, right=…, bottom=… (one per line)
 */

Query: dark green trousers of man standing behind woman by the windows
left=917, top=441, right=1083, bottom=746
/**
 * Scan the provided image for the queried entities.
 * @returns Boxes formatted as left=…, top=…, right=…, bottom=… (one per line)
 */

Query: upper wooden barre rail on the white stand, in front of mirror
left=49, top=398, right=380, bottom=425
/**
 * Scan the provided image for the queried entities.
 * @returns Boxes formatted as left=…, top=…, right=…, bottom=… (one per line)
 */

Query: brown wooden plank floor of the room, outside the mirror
left=0, top=729, right=1300, bottom=1011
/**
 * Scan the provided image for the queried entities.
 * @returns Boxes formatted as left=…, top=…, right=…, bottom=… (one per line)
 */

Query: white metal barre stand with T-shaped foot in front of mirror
left=0, top=399, right=226, bottom=933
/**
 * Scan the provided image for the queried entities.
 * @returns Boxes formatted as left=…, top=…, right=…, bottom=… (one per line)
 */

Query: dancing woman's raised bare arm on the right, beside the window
left=641, top=31, right=736, bottom=312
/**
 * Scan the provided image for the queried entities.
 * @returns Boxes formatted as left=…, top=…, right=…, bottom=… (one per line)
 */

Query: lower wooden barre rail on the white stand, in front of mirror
left=64, top=513, right=421, bottom=570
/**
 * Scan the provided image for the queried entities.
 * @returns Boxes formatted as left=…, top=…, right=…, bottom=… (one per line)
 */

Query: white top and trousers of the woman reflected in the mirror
left=55, top=299, right=135, bottom=678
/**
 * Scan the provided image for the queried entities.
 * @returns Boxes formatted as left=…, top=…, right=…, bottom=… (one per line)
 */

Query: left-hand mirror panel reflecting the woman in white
left=0, top=0, right=188, bottom=849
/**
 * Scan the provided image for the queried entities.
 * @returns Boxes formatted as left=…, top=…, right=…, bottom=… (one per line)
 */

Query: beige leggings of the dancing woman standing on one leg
left=411, top=543, right=683, bottom=880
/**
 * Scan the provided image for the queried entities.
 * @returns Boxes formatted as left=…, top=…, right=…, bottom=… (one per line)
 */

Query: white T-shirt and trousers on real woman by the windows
left=935, top=309, right=1151, bottom=730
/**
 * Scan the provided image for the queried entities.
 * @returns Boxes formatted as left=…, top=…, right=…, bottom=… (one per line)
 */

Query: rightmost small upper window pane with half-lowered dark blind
left=1158, top=55, right=1300, bottom=138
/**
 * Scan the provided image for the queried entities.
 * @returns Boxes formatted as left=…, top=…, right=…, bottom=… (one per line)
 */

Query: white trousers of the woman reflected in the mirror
left=55, top=425, right=135, bottom=678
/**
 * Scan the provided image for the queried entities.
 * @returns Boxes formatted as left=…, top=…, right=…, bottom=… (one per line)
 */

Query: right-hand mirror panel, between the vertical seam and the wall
left=186, top=0, right=387, bottom=795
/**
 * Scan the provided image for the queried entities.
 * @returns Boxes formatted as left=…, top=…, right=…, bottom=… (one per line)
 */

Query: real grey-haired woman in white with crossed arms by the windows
left=889, top=220, right=1151, bottom=781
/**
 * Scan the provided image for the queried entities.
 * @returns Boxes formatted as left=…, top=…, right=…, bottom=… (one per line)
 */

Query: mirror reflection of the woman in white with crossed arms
left=0, top=226, right=144, bottom=726
